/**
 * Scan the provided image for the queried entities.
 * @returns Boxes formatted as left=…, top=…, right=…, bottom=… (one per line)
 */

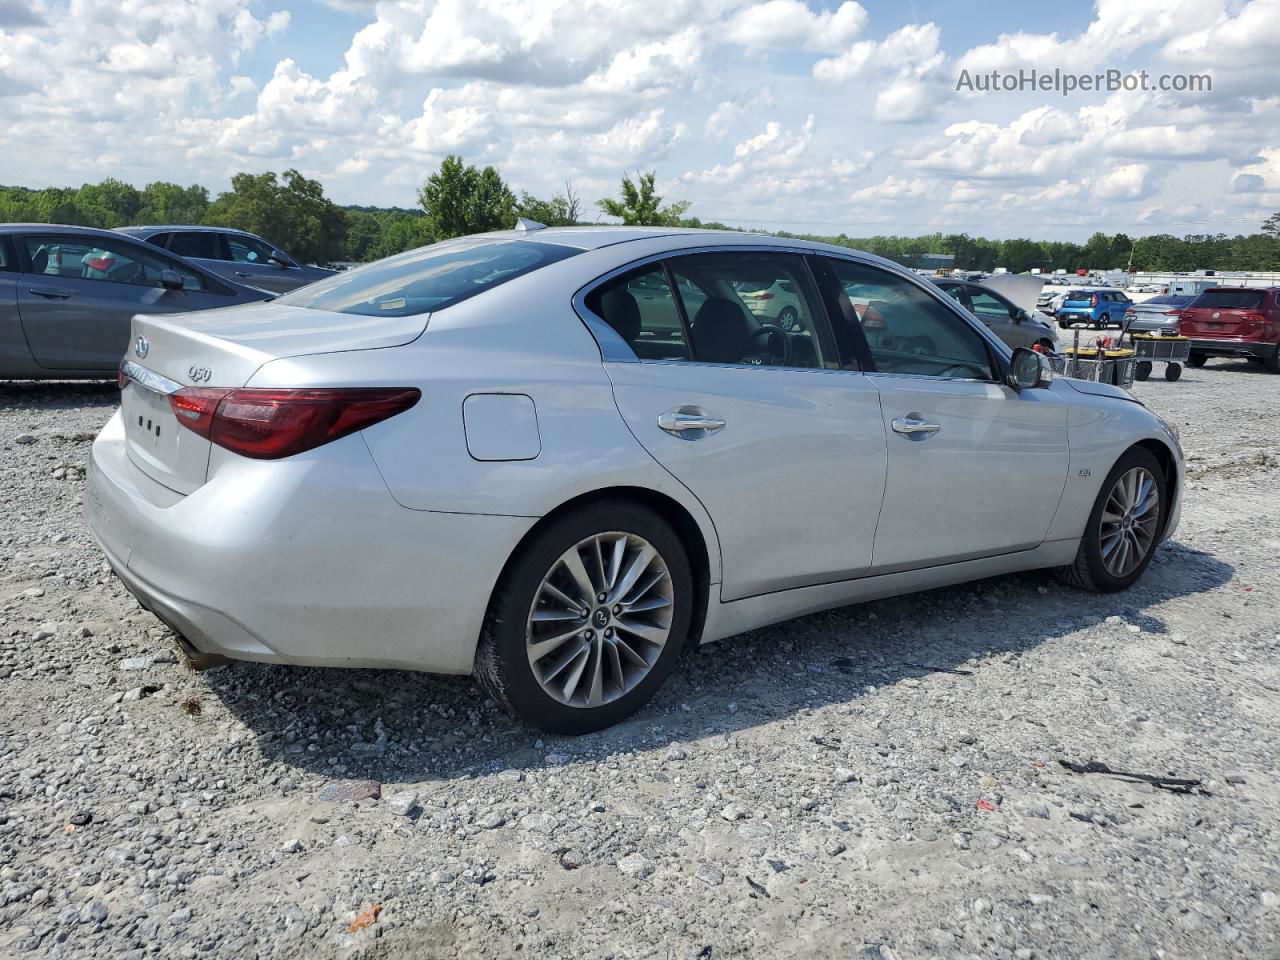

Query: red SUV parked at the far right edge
left=1178, top=287, right=1280, bottom=374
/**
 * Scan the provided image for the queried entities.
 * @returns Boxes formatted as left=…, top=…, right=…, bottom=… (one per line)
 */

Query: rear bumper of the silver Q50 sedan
left=84, top=413, right=535, bottom=673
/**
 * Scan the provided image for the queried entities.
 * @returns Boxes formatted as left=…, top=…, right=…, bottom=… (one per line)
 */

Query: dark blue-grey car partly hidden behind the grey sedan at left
left=119, top=227, right=334, bottom=293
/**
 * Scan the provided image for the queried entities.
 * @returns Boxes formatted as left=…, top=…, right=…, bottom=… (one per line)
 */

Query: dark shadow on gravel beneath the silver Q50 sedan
left=205, top=541, right=1234, bottom=783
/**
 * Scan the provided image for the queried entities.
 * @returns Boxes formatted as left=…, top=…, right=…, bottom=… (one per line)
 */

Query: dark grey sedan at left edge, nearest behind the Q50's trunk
left=0, top=224, right=270, bottom=380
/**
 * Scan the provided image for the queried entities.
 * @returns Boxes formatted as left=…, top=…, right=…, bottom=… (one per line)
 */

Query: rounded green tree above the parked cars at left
left=205, top=170, right=347, bottom=264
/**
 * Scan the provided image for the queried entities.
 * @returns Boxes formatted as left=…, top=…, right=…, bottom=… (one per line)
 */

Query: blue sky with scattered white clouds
left=0, top=0, right=1280, bottom=241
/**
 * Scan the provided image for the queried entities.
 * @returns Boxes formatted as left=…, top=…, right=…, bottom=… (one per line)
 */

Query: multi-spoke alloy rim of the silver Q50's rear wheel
left=525, top=531, right=675, bottom=708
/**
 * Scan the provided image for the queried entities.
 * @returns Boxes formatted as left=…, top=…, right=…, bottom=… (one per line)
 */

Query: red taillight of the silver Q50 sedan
left=169, top=387, right=422, bottom=460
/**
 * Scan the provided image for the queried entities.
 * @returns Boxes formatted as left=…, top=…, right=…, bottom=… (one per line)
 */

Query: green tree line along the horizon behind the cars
left=0, top=156, right=1280, bottom=273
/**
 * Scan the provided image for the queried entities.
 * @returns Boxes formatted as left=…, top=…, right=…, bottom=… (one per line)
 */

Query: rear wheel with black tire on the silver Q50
left=475, top=500, right=694, bottom=735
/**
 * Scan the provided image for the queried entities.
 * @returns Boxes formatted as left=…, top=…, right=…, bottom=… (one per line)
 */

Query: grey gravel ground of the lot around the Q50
left=0, top=361, right=1280, bottom=960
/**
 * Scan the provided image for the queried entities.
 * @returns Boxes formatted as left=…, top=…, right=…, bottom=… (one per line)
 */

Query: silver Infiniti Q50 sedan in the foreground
left=86, top=227, right=1183, bottom=733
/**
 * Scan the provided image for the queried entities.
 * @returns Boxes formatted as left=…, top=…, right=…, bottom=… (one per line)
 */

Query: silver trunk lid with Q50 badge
left=120, top=302, right=428, bottom=494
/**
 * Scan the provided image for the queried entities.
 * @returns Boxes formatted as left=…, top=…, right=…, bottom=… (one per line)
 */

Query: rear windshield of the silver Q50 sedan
left=275, top=239, right=582, bottom=316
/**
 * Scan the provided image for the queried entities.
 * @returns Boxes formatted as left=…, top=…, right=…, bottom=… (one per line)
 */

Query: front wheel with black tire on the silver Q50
left=1057, top=447, right=1169, bottom=593
